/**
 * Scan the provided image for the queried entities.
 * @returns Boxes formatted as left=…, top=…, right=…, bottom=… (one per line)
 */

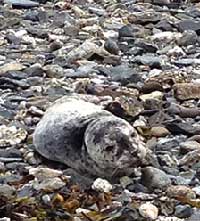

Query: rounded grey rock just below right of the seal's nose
left=141, top=167, right=171, bottom=190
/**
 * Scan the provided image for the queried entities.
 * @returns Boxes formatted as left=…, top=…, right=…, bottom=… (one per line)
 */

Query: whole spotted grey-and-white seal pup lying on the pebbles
left=33, top=96, right=146, bottom=179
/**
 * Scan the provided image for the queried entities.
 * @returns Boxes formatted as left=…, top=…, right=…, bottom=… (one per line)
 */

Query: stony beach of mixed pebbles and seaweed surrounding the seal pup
left=0, top=0, right=200, bottom=221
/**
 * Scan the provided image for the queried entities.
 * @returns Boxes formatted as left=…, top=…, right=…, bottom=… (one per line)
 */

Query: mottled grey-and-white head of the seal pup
left=85, top=116, right=146, bottom=174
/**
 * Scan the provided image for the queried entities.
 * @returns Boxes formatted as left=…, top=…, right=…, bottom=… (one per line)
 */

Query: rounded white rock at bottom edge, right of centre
left=139, top=202, right=158, bottom=220
